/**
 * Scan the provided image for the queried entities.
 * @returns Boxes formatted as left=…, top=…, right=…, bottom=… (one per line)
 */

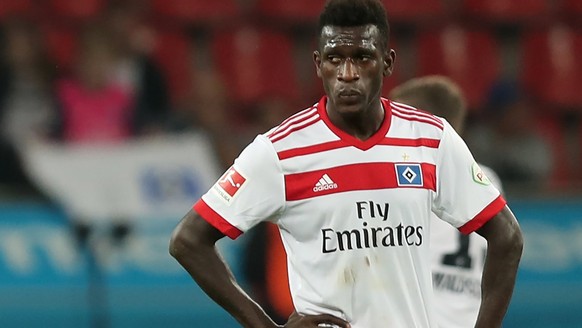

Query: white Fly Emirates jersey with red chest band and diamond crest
left=194, top=97, right=505, bottom=328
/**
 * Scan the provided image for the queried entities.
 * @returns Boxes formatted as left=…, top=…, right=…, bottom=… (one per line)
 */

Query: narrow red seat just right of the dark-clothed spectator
left=153, top=30, right=194, bottom=103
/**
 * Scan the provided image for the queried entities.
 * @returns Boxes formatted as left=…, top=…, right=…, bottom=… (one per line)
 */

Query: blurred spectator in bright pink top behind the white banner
left=57, top=25, right=133, bottom=142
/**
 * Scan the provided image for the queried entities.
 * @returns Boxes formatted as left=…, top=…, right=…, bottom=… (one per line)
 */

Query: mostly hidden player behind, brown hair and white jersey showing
left=389, top=76, right=501, bottom=328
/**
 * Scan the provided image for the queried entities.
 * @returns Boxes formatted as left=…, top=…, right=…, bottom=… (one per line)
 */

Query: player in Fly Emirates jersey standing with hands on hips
left=170, top=0, right=522, bottom=328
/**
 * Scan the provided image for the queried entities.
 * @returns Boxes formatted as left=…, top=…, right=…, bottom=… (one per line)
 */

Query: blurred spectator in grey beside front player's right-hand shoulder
left=467, top=81, right=554, bottom=189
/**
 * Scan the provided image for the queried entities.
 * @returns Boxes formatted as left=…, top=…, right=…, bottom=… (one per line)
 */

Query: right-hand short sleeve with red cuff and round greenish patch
left=432, top=120, right=506, bottom=234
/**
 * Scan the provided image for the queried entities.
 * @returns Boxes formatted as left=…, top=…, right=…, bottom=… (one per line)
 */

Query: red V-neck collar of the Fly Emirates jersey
left=317, top=96, right=392, bottom=150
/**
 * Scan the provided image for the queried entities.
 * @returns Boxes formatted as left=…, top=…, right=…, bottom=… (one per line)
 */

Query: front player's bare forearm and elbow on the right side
left=475, top=205, right=523, bottom=328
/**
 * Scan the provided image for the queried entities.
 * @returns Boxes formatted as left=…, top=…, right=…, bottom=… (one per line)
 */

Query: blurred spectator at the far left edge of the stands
left=0, top=18, right=57, bottom=195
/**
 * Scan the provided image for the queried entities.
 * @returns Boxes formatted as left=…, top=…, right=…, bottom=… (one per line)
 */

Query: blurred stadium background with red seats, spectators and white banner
left=0, top=0, right=582, bottom=328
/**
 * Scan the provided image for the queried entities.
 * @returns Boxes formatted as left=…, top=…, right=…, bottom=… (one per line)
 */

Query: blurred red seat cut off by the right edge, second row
left=521, top=24, right=582, bottom=110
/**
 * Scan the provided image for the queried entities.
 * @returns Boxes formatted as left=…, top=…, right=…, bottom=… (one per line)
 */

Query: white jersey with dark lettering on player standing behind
left=430, top=166, right=502, bottom=328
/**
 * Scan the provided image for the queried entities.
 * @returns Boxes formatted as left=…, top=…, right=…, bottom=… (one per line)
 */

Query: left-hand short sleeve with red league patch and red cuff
left=194, top=135, right=285, bottom=239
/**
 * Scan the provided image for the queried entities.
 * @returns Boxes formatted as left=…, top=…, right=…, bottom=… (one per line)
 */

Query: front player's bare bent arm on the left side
left=170, top=210, right=278, bottom=328
